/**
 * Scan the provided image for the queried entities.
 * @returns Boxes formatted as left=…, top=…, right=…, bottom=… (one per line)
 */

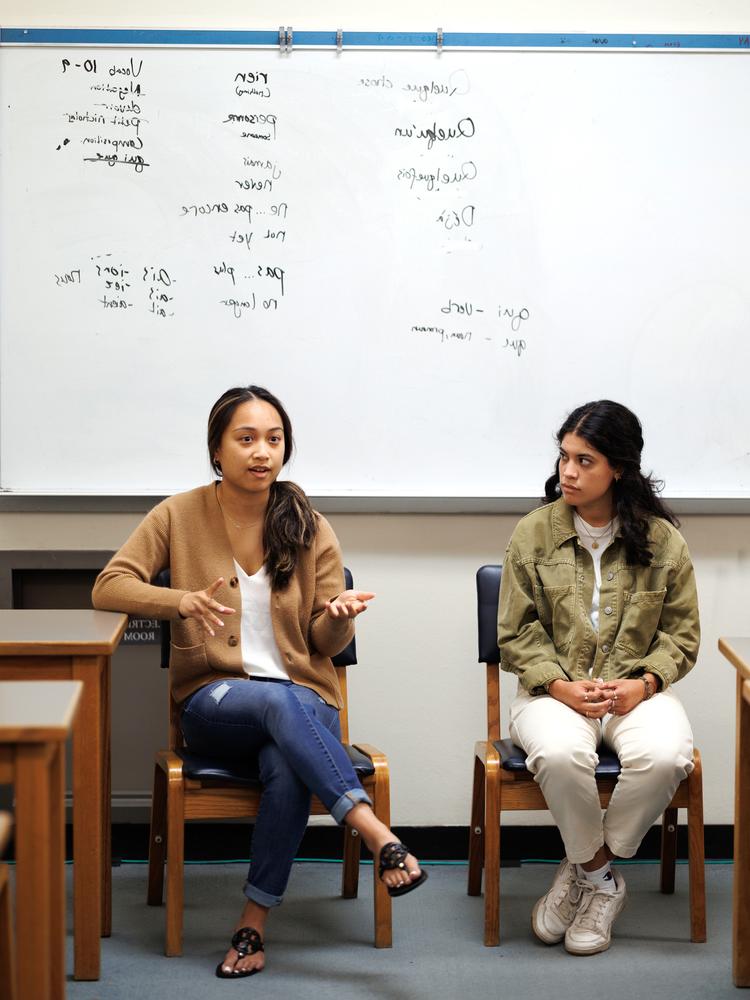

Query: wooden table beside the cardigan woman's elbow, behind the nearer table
left=0, top=610, right=127, bottom=980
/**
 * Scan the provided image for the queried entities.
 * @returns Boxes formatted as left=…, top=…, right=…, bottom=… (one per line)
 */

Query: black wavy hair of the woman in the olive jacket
left=542, top=399, right=679, bottom=566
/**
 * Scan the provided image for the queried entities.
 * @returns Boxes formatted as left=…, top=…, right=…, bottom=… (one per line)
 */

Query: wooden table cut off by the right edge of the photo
left=719, top=638, right=750, bottom=986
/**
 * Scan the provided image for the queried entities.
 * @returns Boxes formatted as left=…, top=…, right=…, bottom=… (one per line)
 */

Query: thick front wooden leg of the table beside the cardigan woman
left=72, top=656, right=104, bottom=979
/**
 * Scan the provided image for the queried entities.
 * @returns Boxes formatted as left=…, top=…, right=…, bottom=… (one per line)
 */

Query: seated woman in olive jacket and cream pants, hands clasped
left=498, top=400, right=700, bottom=955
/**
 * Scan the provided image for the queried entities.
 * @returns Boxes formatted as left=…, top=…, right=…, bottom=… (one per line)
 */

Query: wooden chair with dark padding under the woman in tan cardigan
left=148, top=569, right=392, bottom=956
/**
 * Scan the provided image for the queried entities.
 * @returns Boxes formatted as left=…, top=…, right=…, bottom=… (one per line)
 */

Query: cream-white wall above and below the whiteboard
left=0, top=0, right=750, bottom=825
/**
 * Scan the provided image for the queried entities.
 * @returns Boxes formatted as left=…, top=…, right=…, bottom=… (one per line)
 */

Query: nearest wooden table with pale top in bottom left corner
left=0, top=681, right=83, bottom=1000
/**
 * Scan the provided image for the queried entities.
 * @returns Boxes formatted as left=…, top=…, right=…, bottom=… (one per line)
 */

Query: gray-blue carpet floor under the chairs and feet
left=67, top=863, right=741, bottom=1000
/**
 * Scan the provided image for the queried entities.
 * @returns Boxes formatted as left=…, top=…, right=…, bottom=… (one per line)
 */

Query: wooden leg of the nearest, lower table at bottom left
left=15, top=744, right=55, bottom=1000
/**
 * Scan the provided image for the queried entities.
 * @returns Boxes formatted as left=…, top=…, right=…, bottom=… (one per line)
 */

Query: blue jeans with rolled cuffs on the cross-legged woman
left=181, top=678, right=372, bottom=906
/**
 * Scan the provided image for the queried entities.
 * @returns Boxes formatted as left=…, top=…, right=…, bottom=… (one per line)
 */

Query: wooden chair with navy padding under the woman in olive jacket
left=468, top=566, right=706, bottom=945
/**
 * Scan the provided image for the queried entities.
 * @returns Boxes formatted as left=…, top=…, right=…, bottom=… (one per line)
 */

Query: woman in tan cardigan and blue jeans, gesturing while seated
left=93, top=386, right=427, bottom=978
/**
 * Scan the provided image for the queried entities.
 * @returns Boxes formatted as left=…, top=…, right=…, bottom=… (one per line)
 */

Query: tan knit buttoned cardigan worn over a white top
left=92, top=483, right=354, bottom=709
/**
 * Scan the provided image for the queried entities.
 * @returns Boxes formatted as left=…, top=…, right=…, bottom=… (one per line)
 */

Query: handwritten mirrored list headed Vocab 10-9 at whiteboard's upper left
left=57, top=56, right=150, bottom=174
